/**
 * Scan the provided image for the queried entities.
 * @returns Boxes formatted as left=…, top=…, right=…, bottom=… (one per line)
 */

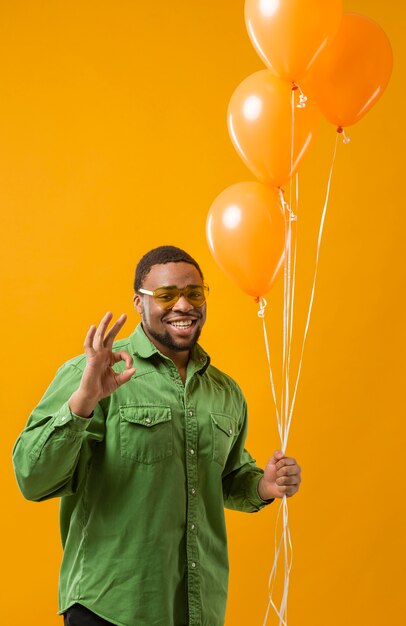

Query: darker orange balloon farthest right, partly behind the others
left=303, top=13, right=393, bottom=127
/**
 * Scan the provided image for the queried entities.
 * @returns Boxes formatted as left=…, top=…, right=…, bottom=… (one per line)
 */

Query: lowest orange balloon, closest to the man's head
left=206, top=181, right=285, bottom=297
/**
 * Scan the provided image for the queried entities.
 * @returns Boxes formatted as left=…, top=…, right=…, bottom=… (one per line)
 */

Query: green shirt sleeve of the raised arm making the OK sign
left=13, top=363, right=105, bottom=501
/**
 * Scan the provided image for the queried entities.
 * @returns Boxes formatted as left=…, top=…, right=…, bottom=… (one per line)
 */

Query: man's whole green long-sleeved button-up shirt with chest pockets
left=14, top=325, right=272, bottom=626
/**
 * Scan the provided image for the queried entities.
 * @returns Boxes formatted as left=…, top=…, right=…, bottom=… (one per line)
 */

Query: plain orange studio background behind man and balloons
left=0, top=0, right=406, bottom=626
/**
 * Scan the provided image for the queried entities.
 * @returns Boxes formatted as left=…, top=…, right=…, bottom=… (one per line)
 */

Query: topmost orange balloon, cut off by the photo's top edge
left=245, top=0, right=343, bottom=81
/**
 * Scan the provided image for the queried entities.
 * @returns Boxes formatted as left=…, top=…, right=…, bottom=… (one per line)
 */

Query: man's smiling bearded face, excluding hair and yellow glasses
left=134, top=262, right=206, bottom=360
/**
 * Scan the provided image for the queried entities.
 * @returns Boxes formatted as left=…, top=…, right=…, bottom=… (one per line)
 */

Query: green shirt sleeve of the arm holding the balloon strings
left=223, top=399, right=273, bottom=513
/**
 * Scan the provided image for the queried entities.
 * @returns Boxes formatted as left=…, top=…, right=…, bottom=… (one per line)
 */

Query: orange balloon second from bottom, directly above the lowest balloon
left=227, top=70, right=319, bottom=187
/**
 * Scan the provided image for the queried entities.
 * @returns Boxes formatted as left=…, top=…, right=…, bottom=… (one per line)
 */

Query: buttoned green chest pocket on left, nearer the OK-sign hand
left=120, top=405, right=173, bottom=465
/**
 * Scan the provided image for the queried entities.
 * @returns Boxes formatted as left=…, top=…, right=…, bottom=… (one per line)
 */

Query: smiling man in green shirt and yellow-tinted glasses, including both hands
left=14, top=246, right=300, bottom=626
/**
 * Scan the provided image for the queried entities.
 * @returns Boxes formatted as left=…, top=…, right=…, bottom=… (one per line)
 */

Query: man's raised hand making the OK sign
left=69, top=313, right=135, bottom=417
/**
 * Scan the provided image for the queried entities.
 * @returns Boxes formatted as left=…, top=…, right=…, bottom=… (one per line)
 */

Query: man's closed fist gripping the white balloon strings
left=258, top=450, right=302, bottom=500
